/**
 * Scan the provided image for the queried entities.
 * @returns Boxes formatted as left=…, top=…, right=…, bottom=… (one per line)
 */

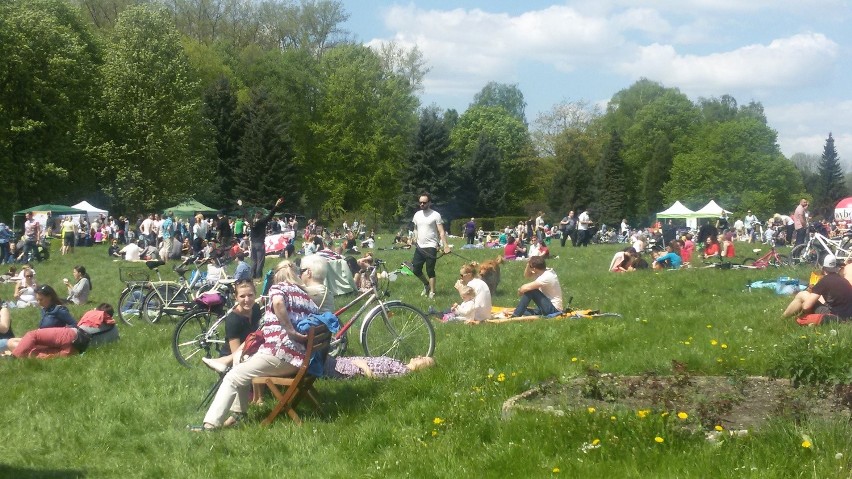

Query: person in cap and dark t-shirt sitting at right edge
left=784, top=254, right=852, bottom=318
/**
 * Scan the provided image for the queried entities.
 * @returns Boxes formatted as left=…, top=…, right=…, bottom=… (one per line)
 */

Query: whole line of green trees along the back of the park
left=0, top=0, right=846, bottom=229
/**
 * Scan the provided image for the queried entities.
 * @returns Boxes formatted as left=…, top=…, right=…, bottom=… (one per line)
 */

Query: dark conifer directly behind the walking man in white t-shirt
left=400, top=108, right=456, bottom=216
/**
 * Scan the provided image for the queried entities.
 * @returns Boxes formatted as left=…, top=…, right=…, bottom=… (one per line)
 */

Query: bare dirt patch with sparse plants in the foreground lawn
left=503, top=373, right=852, bottom=431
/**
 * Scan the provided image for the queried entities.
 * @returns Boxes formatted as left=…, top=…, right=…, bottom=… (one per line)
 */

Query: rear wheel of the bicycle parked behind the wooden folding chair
left=172, top=311, right=225, bottom=368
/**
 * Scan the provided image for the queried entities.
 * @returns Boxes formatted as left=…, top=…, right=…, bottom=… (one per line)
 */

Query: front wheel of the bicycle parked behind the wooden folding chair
left=361, top=303, right=435, bottom=363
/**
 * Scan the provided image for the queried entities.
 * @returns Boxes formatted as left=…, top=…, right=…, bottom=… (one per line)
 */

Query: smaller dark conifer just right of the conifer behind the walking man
left=468, top=133, right=506, bottom=216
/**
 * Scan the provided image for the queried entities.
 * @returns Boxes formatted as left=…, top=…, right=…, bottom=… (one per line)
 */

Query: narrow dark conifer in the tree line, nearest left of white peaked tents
left=592, top=130, right=627, bottom=225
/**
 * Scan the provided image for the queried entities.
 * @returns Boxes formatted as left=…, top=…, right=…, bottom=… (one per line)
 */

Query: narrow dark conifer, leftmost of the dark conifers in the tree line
left=204, top=75, right=242, bottom=207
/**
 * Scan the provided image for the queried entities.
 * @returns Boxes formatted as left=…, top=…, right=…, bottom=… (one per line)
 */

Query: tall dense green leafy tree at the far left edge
left=0, top=0, right=101, bottom=217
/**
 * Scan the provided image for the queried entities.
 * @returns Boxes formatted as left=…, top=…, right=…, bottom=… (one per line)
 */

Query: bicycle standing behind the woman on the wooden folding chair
left=172, top=260, right=435, bottom=367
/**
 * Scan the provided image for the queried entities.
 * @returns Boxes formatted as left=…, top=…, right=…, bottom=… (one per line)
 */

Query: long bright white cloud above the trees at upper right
left=618, top=33, right=839, bottom=94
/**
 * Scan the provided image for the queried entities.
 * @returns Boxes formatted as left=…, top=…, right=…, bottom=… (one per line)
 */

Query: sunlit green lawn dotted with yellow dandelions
left=0, top=236, right=852, bottom=478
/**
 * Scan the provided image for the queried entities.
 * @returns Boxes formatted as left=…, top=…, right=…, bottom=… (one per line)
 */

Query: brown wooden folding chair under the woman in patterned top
left=252, top=325, right=331, bottom=425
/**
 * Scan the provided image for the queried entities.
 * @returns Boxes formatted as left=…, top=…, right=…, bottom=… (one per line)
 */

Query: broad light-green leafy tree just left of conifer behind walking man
left=312, top=45, right=419, bottom=219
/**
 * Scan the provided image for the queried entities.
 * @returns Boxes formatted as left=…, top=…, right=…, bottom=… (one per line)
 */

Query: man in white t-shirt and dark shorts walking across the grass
left=411, top=192, right=450, bottom=299
